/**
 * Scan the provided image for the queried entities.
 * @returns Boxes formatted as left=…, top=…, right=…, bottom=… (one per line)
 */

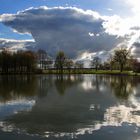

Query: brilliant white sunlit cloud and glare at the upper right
left=103, top=0, right=140, bottom=57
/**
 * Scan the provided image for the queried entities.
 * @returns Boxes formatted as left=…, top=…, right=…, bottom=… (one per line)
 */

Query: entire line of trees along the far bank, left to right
left=0, top=48, right=140, bottom=74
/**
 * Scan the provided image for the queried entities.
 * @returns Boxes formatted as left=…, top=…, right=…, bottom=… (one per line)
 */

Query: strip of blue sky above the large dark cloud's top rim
left=0, top=0, right=131, bottom=15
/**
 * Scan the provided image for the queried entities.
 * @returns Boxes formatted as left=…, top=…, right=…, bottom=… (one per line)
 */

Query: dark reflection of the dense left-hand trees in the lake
left=0, top=76, right=37, bottom=102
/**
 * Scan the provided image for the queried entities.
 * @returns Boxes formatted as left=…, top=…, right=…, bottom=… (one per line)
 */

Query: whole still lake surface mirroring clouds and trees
left=0, top=75, right=140, bottom=140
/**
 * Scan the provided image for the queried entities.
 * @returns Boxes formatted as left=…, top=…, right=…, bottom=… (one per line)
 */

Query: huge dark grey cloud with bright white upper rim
left=1, top=7, right=122, bottom=57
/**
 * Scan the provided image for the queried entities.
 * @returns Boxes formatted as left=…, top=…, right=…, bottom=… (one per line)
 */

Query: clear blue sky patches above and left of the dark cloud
left=0, top=0, right=129, bottom=39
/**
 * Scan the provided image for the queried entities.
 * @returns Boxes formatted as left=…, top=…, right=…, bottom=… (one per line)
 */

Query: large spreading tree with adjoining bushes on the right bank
left=100, top=48, right=140, bottom=72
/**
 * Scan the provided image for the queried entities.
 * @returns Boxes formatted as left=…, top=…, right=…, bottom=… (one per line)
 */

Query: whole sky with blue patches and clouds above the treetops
left=0, top=0, right=140, bottom=63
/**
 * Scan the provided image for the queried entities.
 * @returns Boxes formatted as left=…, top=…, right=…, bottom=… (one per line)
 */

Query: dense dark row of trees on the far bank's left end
left=0, top=50, right=36, bottom=74
